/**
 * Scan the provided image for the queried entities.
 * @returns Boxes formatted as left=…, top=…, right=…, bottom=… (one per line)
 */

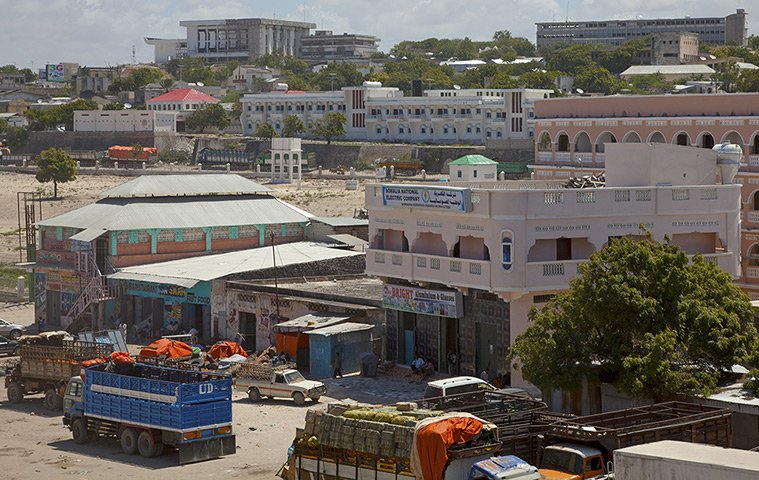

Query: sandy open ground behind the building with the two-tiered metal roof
left=0, top=167, right=372, bottom=264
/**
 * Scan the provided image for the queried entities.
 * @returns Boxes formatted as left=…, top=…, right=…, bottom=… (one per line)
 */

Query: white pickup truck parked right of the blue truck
left=235, top=368, right=327, bottom=405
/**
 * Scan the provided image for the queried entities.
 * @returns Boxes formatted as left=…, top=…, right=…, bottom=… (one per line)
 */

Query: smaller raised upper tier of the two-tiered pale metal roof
left=100, top=173, right=274, bottom=198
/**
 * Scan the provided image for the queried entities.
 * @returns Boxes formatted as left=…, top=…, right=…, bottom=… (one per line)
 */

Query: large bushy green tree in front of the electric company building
left=510, top=235, right=757, bottom=400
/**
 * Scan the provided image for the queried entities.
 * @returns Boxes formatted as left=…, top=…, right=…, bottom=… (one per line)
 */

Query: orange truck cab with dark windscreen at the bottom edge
left=540, top=443, right=604, bottom=480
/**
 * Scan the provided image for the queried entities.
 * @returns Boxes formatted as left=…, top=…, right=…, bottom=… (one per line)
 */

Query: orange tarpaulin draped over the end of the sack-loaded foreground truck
left=416, top=417, right=482, bottom=480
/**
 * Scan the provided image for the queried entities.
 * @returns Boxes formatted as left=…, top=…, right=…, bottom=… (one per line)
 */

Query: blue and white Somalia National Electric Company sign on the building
left=382, top=185, right=472, bottom=212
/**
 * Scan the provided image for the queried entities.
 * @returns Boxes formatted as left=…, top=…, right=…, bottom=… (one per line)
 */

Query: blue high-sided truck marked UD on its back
left=63, top=363, right=236, bottom=464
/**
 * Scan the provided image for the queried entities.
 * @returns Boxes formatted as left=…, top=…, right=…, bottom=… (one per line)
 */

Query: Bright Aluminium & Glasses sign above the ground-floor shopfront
left=382, top=283, right=464, bottom=318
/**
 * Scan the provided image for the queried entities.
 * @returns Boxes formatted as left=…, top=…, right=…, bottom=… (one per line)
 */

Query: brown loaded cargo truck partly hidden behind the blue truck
left=5, top=339, right=113, bottom=410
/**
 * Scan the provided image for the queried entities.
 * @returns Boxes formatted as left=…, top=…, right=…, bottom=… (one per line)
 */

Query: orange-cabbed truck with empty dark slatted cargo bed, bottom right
left=538, top=402, right=732, bottom=480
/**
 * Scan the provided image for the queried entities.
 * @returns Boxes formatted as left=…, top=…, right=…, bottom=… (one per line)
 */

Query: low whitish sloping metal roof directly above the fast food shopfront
left=109, top=242, right=363, bottom=284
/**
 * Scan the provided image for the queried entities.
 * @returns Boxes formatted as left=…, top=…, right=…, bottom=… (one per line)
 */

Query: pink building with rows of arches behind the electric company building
left=534, top=93, right=759, bottom=300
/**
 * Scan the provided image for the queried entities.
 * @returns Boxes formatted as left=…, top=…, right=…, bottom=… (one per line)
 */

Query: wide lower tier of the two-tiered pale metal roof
left=37, top=195, right=309, bottom=231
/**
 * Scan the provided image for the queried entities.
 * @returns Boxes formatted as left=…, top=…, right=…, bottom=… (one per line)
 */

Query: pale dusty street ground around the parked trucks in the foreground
left=0, top=303, right=424, bottom=480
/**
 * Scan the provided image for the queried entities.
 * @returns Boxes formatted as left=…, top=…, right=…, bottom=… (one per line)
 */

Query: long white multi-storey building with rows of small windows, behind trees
left=240, top=82, right=553, bottom=144
